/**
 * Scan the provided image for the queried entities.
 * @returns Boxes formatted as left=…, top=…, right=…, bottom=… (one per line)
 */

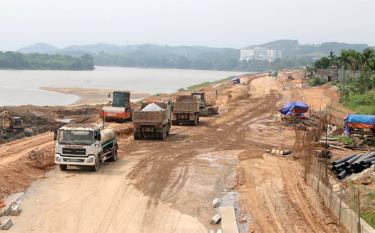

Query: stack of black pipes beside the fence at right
left=332, top=152, right=375, bottom=180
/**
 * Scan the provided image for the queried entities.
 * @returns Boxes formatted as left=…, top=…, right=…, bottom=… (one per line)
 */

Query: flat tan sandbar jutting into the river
left=41, top=87, right=149, bottom=106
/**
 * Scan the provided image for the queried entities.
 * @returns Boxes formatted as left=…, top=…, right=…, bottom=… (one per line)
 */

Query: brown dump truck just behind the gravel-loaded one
left=172, top=95, right=200, bottom=125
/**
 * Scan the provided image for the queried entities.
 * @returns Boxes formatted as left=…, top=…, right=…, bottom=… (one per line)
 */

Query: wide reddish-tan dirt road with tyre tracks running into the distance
left=2, top=72, right=342, bottom=233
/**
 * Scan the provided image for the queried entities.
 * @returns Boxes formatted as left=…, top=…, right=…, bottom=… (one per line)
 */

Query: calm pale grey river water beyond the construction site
left=0, top=67, right=247, bottom=106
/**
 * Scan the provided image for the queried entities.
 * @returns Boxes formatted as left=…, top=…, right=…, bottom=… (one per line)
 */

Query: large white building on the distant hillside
left=240, top=47, right=282, bottom=62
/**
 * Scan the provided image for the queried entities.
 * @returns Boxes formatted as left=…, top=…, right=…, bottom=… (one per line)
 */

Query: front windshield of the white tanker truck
left=59, top=130, right=94, bottom=145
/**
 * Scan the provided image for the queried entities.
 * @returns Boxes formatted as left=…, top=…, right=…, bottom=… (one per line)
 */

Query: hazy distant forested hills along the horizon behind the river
left=19, top=40, right=374, bottom=71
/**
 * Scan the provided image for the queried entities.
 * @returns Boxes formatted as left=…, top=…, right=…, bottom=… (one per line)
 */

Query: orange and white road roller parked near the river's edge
left=100, top=91, right=132, bottom=122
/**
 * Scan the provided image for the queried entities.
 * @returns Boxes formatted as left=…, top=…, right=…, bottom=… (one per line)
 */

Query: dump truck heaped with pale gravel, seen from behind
left=133, top=101, right=172, bottom=140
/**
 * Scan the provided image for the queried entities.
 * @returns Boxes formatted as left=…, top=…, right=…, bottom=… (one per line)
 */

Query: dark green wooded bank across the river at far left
left=0, top=52, right=94, bottom=70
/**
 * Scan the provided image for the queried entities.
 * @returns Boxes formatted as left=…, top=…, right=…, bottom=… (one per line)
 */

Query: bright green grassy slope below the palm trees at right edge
left=343, top=91, right=375, bottom=115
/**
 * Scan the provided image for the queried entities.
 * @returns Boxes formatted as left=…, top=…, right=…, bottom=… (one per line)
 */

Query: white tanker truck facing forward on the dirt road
left=54, top=124, right=118, bottom=171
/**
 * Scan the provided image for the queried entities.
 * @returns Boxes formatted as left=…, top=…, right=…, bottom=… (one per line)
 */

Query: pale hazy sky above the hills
left=0, top=0, right=375, bottom=50
